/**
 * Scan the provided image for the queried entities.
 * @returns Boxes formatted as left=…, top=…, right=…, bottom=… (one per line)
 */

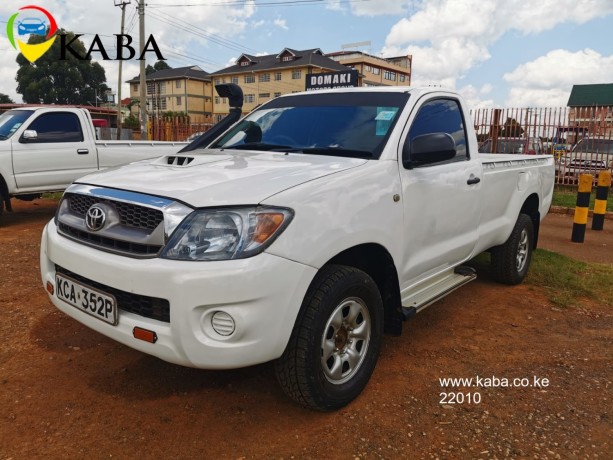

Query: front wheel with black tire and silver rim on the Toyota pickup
left=275, top=265, right=383, bottom=411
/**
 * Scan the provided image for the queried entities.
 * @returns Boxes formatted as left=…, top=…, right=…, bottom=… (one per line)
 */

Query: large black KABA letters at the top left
left=60, top=34, right=166, bottom=61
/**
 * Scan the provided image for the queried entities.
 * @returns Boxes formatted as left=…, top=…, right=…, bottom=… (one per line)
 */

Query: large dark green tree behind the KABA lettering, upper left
left=15, top=30, right=109, bottom=105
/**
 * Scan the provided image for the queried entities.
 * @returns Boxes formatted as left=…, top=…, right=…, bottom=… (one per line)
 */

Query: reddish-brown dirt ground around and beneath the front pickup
left=0, top=200, right=613, bottom=459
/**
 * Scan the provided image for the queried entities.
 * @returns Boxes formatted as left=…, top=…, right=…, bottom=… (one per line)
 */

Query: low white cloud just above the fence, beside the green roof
left=503, top=49, right=613, bottom=107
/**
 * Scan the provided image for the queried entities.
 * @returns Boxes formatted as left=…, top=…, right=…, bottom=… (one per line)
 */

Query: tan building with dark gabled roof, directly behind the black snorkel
left=210, top=48, right=347, bottom=121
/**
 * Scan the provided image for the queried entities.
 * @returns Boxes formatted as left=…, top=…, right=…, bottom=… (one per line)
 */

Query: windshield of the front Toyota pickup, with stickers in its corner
left=210, top=92, right=409, bottom=159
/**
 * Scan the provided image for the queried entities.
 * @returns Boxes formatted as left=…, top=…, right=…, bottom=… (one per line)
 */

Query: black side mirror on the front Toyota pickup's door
left=402, top=133, right=457, bottom=169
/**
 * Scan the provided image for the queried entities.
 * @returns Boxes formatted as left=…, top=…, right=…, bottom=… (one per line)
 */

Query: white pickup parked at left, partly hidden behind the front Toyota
left=0, top=107, right=185, bottom=214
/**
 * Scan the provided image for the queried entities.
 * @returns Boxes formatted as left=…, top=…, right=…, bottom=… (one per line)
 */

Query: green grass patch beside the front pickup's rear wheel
left=469, top=249, right=613, bottom=307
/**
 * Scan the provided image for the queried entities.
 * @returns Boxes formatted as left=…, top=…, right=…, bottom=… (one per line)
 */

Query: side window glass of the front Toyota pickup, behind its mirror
left=407, top=99, right=468, bottom=167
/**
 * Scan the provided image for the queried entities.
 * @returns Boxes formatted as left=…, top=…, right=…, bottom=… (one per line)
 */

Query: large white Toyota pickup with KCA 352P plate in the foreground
left=40, top=87, right=554, bottom=411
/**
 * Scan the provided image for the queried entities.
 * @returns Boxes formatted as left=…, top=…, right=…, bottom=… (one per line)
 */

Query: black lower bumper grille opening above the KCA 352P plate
left=55, top=265, right=170, bottom=323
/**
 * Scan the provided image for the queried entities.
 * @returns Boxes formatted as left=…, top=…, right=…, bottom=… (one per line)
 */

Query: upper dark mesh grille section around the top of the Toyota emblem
left=66, top=193, right=164, bottom=231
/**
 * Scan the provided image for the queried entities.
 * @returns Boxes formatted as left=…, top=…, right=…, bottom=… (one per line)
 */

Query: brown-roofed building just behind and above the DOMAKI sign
left=326, top=51, right=413, bottom=86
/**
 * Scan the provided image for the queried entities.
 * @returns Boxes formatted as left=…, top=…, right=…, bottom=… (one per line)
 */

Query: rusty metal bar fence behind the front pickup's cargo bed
left=471, top=107, right=613, bottom=185
